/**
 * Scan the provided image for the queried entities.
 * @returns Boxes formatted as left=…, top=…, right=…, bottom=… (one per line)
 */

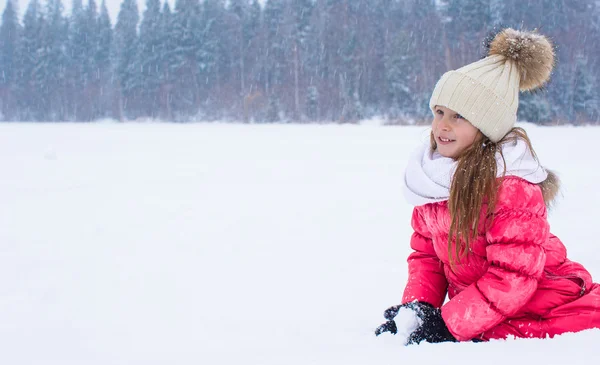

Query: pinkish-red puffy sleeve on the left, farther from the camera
left=402, top=208, right=448, bottom=308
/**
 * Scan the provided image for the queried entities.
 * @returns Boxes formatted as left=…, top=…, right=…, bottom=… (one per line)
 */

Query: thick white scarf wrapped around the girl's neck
left=404, top=139, right=548, bottom=206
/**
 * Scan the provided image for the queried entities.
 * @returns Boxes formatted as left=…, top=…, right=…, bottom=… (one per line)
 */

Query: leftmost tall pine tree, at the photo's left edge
left=0, top=0, right=21, bottom=120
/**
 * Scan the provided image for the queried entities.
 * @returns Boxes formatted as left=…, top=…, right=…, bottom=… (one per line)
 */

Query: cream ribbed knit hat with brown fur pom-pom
left=429, top=28, right=554, bottom=142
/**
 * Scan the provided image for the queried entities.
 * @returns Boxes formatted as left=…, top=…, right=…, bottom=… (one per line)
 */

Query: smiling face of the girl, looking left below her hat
left=431, top=105, right=479, bottom=159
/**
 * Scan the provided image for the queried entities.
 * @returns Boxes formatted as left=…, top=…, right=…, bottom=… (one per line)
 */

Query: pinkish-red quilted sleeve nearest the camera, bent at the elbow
left=442, top=178, right=549, bottom=341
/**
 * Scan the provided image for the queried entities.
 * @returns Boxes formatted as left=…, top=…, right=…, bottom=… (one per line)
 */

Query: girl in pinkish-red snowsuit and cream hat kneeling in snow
left=376, top=29, right=600, bottom=344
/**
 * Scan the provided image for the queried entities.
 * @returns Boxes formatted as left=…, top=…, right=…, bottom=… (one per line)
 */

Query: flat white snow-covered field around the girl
left=0, top=123, right=600, bottom=365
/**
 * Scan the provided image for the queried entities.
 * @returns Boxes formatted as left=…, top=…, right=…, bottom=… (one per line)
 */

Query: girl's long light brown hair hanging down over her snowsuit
left=430, top=127, right=540, bottom=266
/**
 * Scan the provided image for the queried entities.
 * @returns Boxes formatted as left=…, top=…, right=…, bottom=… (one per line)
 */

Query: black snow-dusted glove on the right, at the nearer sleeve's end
left=406, top=302, right=456, bottom=345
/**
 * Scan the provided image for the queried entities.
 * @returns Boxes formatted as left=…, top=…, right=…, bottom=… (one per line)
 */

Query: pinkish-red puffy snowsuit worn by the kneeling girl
left=402, top=177, right=600, bottom=341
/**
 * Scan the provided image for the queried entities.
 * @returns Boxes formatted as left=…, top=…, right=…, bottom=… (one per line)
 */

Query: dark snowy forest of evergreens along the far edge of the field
left=0, top=0, right=600, bottom=124
